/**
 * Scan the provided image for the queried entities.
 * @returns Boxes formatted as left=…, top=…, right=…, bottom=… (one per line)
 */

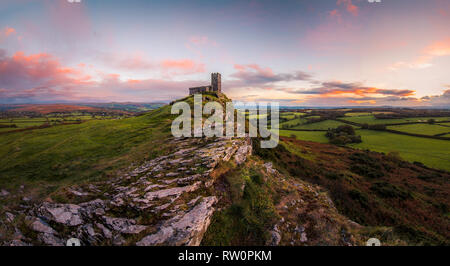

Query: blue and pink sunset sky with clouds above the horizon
left=0, top=0, right=450, bottom=106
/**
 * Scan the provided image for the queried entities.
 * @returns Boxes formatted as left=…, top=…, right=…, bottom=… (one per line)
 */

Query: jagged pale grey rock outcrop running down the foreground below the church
left=3, top=138, right=251, bottom=246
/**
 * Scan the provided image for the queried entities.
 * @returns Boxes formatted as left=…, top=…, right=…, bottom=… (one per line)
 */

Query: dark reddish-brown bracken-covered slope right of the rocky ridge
left=264, top=139, right=450, bottom=245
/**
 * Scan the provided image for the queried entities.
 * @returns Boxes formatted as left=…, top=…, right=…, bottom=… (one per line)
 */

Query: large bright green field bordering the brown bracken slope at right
left=349, top=130, right=450, bottom=171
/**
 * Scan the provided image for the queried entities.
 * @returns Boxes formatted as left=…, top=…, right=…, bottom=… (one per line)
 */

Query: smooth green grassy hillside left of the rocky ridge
left=0, top=103, right=171, bottom=192
